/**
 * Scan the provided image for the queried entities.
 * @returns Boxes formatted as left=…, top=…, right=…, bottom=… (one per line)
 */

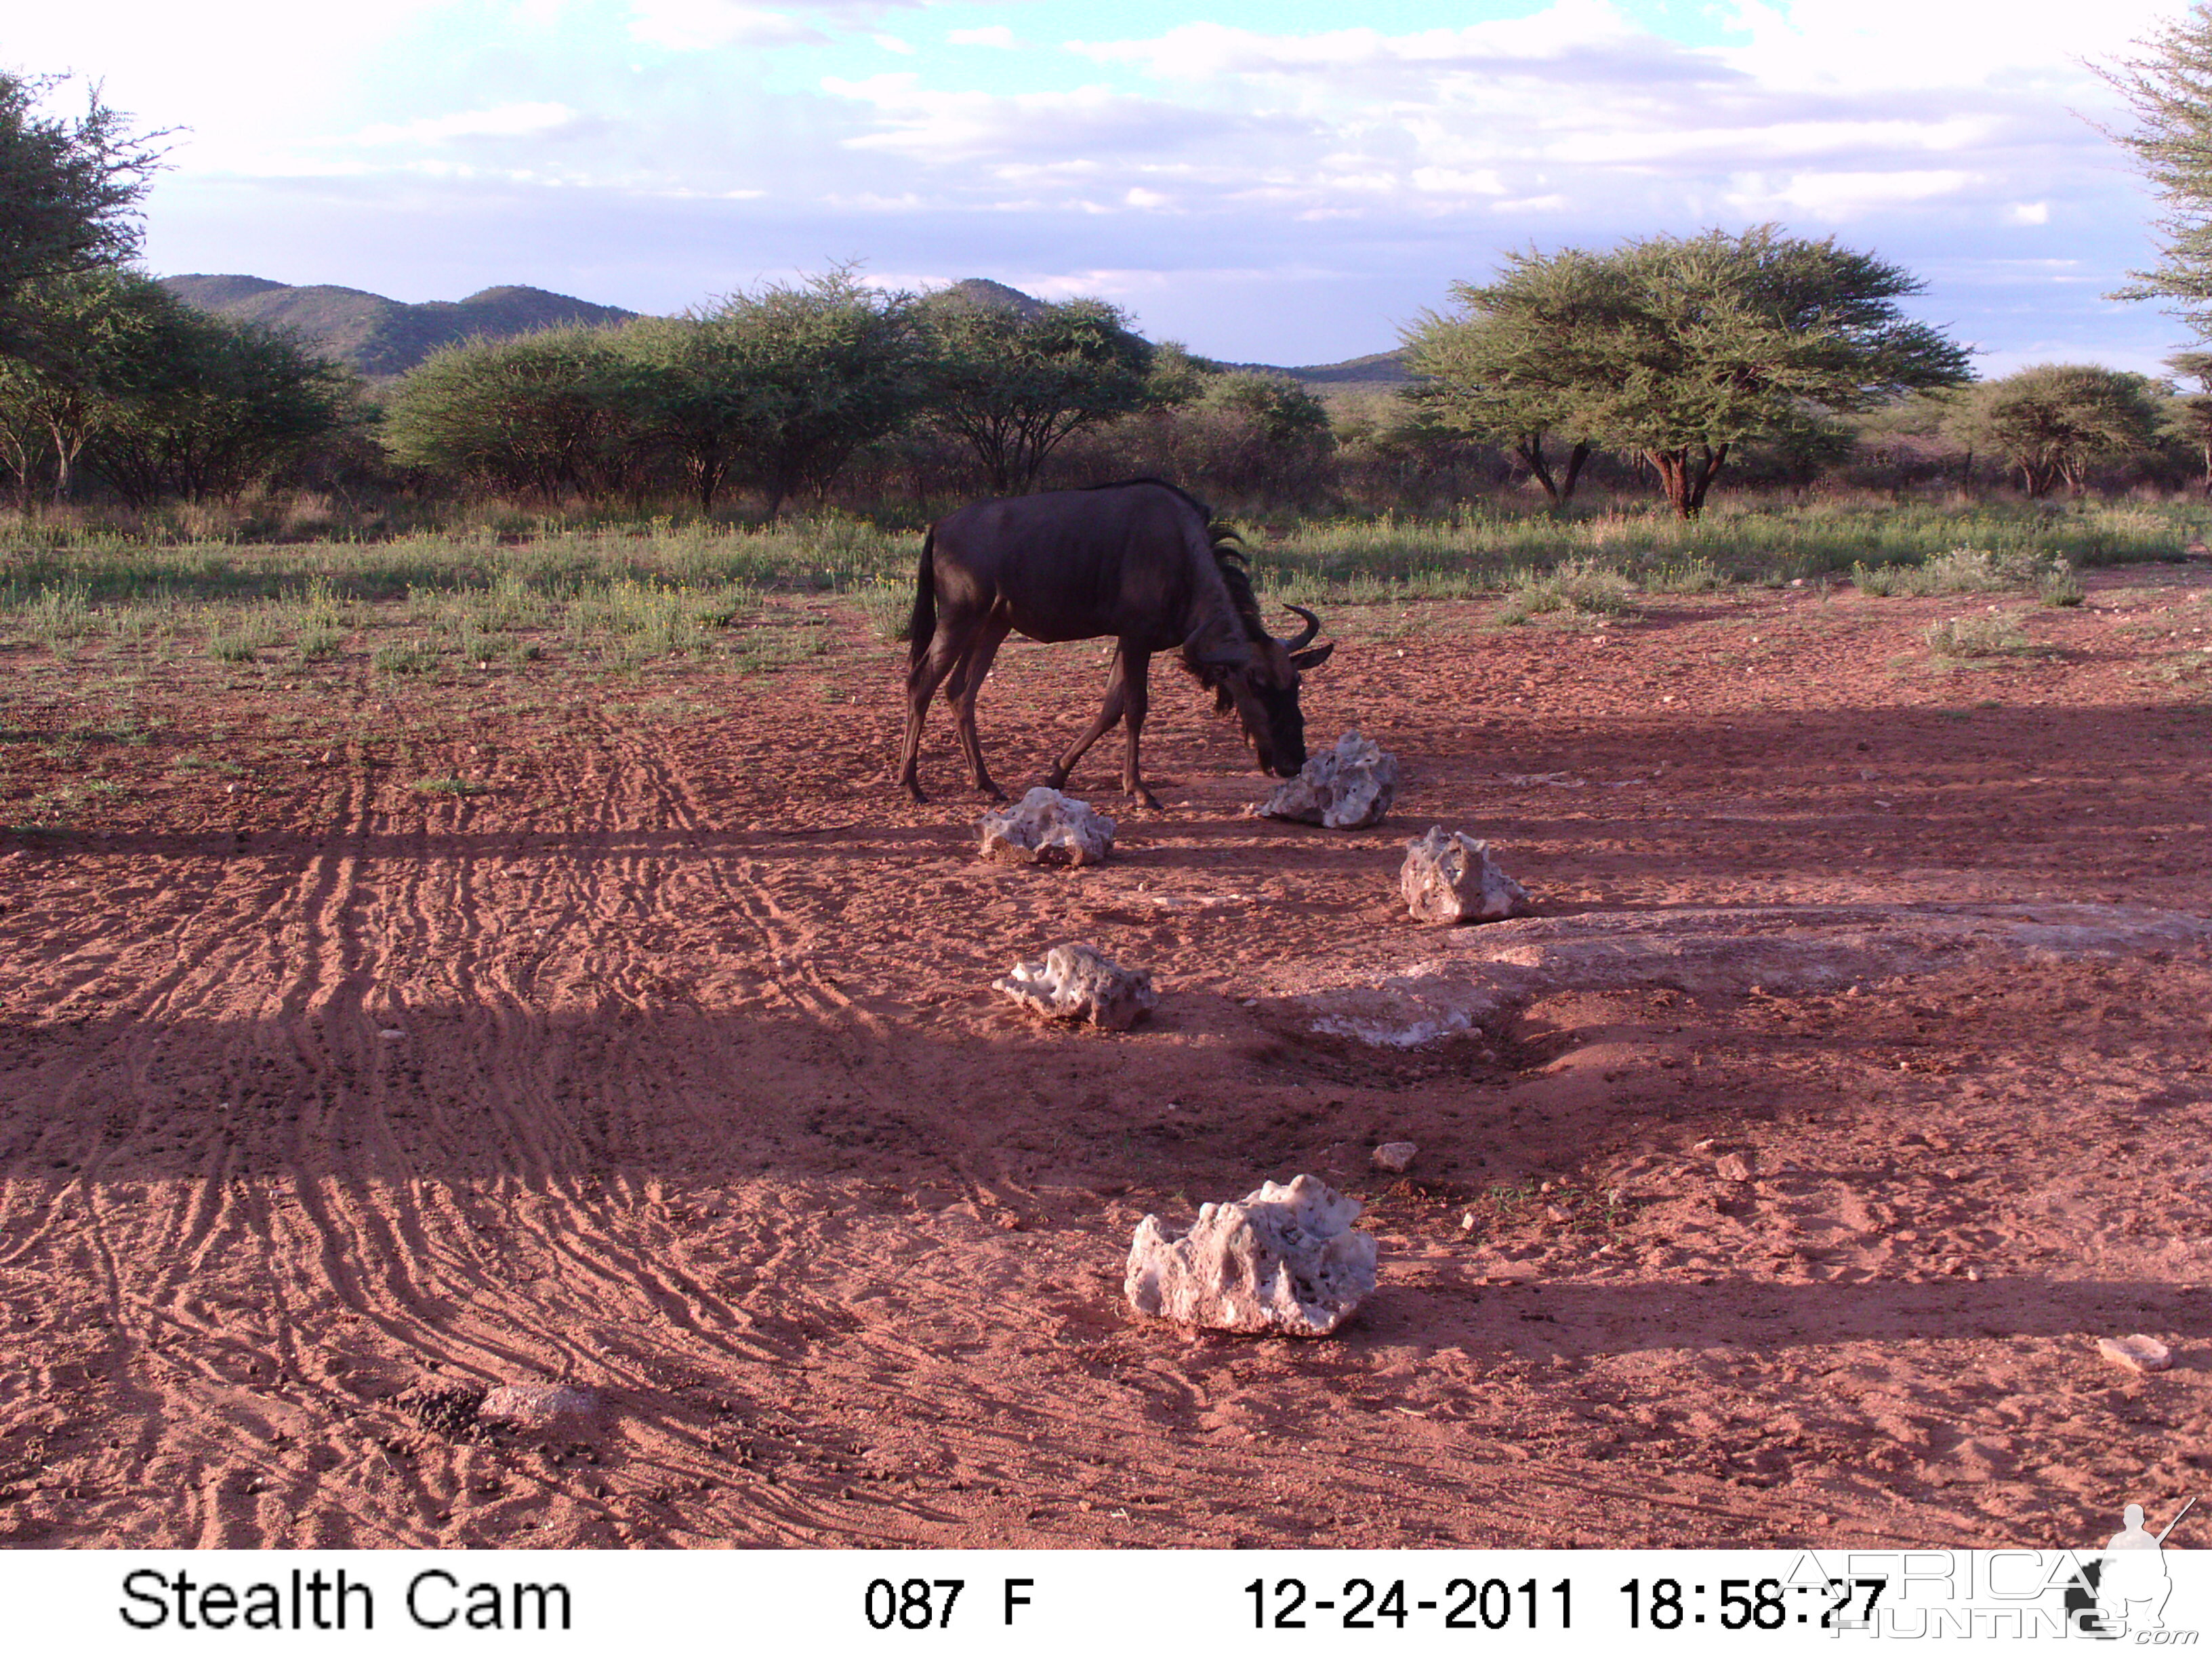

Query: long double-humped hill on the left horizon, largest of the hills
left=161, top=274, right=637, bottom=378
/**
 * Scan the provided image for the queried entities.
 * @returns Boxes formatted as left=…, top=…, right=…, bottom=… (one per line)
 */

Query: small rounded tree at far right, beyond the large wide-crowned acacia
left=1944, top=373, right=2163, bottom=497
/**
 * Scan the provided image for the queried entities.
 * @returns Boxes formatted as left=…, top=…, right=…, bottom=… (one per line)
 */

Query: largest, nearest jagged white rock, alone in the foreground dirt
left=1122, top=1174, right=1376, bottom=1336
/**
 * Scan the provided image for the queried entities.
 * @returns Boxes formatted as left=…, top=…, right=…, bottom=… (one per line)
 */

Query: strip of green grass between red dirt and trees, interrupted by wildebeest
left=0, top=502, right=2205, bottom=672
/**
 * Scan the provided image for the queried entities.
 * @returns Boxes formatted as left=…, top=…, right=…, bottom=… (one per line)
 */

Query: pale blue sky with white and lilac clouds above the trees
left=0, top=0, right=2184, bottom=374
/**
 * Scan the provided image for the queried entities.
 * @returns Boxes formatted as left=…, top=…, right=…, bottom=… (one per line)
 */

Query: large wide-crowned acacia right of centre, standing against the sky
left=1416, top=226, right=1967, bottom=518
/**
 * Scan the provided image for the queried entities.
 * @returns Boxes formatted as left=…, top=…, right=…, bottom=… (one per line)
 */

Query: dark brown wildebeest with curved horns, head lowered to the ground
left=898, top=478, right=1336, bottom=807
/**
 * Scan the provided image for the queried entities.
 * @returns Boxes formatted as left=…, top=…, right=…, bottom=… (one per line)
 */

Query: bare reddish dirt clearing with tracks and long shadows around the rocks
left=0, top=567, right=2212, bottom=1547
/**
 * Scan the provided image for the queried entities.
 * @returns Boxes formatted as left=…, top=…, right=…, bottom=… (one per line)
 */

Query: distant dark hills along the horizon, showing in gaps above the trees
left=161, top=274, right=1409, bottom=389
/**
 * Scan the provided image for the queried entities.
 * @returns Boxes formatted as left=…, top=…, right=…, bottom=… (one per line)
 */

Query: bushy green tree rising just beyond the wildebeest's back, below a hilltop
left=922, top=290, right=1172, bottom=495
